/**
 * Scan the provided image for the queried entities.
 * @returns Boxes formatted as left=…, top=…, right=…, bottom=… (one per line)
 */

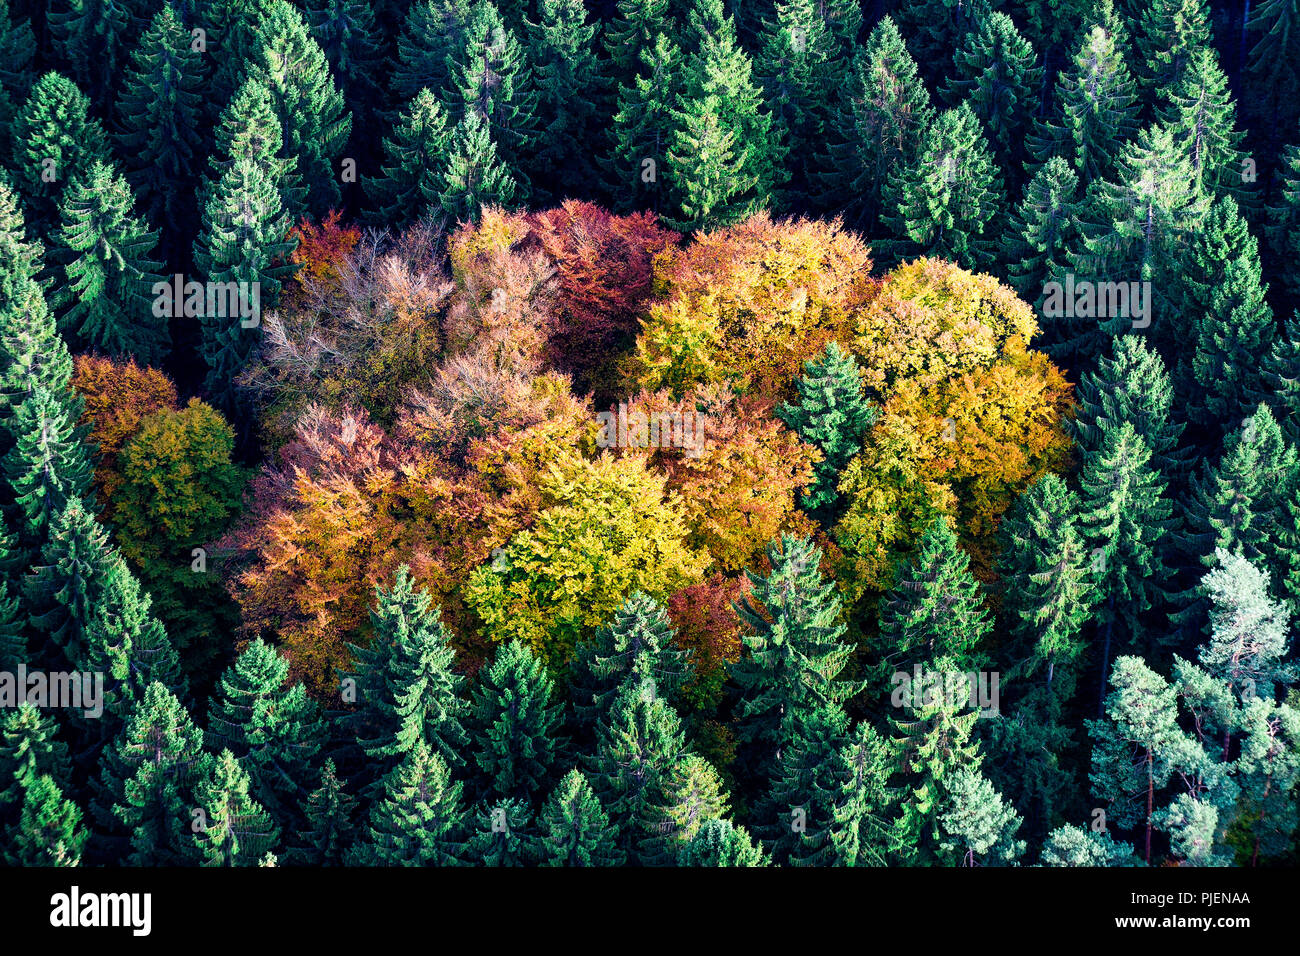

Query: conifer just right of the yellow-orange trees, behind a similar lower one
left=1070, top=333, right=1191, bottom=483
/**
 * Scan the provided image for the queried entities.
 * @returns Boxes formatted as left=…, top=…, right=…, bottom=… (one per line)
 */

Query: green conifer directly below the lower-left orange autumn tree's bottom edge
left=205, top=639, right=325, bottom=821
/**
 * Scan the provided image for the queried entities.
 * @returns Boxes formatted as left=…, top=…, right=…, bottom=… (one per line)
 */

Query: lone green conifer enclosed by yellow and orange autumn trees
left=776, top=341, right=879, bottom=527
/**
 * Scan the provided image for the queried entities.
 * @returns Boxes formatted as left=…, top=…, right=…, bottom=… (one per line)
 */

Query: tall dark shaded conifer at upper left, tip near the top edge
left=114, top=3, right=207, bottom=242
